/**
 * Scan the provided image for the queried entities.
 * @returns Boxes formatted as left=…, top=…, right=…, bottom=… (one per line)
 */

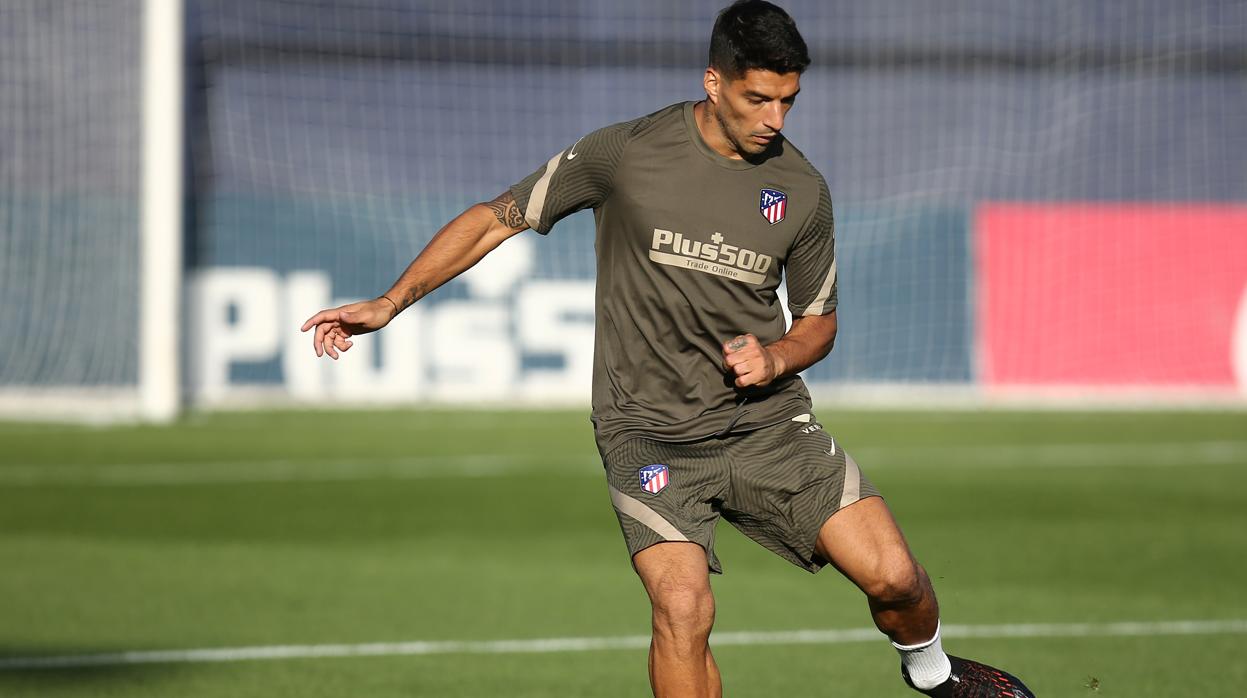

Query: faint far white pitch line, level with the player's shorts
left=0, top=441, right=1247, bottom=486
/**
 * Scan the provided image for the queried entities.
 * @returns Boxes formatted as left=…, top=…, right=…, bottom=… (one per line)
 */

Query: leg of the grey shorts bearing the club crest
left=602, top=439, right=728, bottom=572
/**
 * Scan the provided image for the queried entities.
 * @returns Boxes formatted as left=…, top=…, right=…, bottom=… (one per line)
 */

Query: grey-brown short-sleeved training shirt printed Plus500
left=511, top=102, right=835, bottom=454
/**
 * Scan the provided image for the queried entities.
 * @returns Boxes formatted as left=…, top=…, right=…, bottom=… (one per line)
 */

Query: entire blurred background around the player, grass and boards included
left=0, top=5, right=1247, bottom=698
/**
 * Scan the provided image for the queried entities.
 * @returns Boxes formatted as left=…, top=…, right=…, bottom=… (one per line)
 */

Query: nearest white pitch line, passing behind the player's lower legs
left=0, top=619, right=1247, bottom=671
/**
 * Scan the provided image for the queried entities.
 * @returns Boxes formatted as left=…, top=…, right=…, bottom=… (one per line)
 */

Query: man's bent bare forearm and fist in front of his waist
left=723, top=310, right=835, bottom=388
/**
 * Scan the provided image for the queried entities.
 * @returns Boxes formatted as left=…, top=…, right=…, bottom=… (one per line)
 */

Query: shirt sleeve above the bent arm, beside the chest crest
left=786, top=177, right=835, bottom=318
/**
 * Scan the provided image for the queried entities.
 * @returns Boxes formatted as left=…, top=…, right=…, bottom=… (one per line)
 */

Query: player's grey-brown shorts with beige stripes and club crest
left=604, top=415, right=879, bottom=572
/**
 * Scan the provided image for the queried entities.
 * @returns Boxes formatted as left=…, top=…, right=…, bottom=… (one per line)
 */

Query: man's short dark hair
left=710, top=0, right=809, bottom=79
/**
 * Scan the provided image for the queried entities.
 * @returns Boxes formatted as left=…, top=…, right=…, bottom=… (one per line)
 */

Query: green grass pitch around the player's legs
left=0, top=411, right=1247, bottom=698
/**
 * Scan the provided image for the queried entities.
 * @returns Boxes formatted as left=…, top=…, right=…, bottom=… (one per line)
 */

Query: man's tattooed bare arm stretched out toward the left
left=303, top=191, right=529, bottom=359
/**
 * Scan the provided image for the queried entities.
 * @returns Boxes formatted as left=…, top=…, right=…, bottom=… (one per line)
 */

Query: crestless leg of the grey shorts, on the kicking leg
left=723, top=415, right=879, bottom=572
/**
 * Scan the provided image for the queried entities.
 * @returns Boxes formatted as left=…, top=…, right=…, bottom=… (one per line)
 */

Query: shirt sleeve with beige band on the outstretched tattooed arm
left=511, top=121, right=636, bottom=234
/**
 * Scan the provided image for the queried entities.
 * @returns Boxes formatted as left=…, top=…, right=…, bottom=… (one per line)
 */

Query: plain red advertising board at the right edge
left=975, top=203, right=1247, bottom=389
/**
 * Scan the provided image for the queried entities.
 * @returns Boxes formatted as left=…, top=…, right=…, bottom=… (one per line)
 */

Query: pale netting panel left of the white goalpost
left=0, top=0, right=142, bottom=418
